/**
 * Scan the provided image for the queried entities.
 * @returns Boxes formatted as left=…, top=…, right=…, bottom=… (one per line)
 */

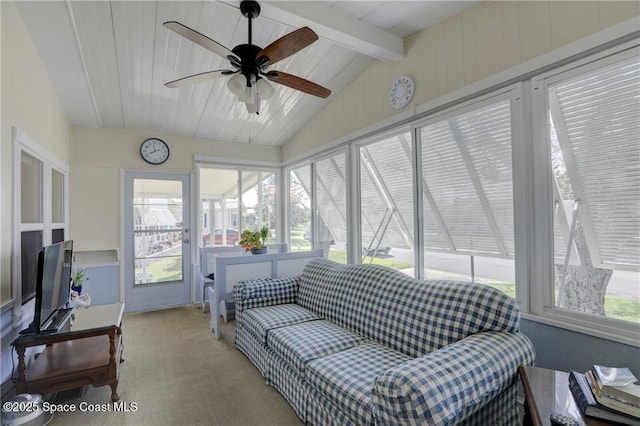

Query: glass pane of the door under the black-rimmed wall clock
left=133, top=179, right=184, bottom=285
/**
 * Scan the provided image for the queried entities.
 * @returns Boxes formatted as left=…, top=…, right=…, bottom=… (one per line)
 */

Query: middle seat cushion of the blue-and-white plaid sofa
left=269, top=321, right=364, bottom=377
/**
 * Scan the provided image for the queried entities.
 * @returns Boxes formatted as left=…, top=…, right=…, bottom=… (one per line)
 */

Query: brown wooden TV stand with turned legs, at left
left=11, top=303, right=124, bottom=401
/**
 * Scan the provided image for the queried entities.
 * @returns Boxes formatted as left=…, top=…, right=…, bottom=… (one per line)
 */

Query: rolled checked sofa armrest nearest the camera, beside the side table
left=372, top=332, right=535, bottom=425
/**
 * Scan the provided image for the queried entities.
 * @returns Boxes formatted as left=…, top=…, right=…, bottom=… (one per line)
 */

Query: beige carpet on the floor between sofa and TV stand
left=50, top=305, right=302, bottom=426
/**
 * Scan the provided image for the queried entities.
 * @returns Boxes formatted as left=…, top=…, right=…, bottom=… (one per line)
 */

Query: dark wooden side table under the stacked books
left=518, top=366, right=614, bottom=426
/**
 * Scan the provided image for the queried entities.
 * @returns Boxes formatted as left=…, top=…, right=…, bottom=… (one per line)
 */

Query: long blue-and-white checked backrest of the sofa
left=298, top=259, right=520, bottom=357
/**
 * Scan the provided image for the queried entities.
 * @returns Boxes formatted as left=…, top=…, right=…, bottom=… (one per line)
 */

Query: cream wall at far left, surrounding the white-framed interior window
left=0, top=1, right=71, bottom=382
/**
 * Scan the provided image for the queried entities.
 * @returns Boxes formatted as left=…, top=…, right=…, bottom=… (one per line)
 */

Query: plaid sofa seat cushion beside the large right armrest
left=306, top=343, right=410, bottom=425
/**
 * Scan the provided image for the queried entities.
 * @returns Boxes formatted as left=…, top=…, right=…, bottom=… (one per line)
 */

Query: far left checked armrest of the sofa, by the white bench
left=233, top=276, right=300, bottom=315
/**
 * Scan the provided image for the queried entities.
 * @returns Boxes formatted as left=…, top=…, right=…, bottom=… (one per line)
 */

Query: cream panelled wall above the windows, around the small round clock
left=283, top=1, right=640, bottom=161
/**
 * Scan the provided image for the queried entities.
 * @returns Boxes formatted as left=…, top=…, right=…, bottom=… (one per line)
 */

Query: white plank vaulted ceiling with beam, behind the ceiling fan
left=17, top=0, right=478, bottom=145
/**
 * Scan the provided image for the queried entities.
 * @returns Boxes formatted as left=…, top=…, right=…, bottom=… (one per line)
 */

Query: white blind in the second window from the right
left=420, top=99, right=514, bottom=257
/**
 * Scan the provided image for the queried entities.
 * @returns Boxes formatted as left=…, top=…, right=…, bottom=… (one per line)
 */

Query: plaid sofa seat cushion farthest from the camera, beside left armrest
left=242, top=304, right=321, bottom=345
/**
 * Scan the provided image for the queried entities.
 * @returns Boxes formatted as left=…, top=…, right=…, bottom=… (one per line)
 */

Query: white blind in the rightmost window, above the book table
left=549, top=57, right=640, bottom=269
